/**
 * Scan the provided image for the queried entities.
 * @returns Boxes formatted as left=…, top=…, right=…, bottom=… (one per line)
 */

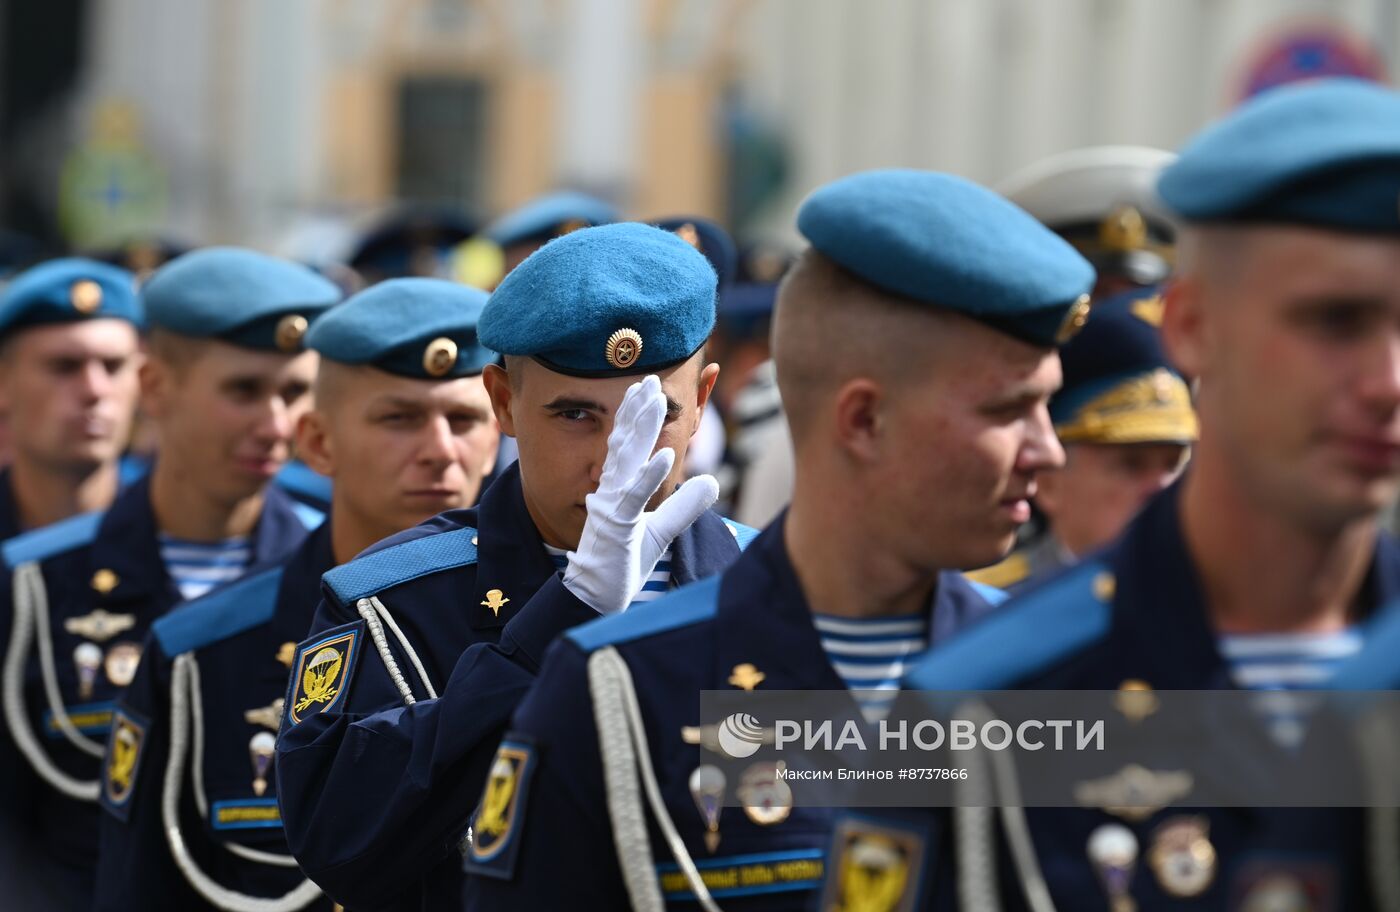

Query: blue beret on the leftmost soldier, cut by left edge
left=0, top=258, right=143, bottom=333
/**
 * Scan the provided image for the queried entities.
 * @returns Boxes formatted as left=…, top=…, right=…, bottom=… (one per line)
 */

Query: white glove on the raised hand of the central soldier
left=564, top=377, right=720, bottom=615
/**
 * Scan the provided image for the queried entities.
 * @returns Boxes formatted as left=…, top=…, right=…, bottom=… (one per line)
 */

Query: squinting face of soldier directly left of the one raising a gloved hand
left=298, top=361, right=500, bottom=537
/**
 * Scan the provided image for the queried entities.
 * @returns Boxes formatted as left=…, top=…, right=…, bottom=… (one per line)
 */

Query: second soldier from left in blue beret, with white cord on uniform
left=0, top=248, right=337, bottom=909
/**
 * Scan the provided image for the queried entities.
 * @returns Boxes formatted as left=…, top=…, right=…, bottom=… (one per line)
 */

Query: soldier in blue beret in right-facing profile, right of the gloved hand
left=466, top=171, right=1093, bottom=911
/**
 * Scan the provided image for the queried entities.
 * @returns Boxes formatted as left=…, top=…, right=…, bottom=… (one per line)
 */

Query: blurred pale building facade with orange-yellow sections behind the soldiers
left=0, top=0, right=1400, bottom=255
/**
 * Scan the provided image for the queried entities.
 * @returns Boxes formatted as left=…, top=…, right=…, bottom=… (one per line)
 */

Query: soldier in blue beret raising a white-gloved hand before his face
left=277, top=223, right=750, bottom=909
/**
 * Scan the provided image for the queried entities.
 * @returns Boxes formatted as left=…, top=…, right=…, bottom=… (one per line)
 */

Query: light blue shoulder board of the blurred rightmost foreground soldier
left=906, top=560, right=1113, bottom=691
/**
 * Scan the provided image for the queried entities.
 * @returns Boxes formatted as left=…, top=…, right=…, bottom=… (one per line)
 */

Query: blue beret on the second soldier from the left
left=141, top=247, right=340, bottom=352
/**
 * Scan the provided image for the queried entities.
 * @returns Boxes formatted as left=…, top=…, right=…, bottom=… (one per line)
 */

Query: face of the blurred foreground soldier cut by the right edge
left=1168, top=227, right=1400, bottom=531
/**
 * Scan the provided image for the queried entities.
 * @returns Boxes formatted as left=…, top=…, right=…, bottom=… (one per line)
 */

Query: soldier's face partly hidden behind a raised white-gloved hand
left=486, top=356, right=720, bottom=549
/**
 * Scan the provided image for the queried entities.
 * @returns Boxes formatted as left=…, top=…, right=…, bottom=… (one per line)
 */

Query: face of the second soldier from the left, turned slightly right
left=143, top=340, right=316, bottom=503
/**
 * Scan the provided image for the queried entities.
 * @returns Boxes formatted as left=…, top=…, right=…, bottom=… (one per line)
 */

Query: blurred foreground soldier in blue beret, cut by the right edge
left=884, top=80, right=1400, bottom=912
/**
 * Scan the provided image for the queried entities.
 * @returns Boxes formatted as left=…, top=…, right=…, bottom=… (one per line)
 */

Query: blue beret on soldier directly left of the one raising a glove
left=307, top=279, right=496, bottom=380
